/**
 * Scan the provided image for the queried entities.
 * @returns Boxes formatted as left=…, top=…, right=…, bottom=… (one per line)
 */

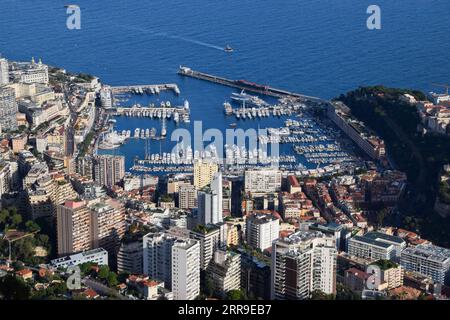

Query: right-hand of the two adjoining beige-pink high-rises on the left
left=89, top=199, right=125, bottom=258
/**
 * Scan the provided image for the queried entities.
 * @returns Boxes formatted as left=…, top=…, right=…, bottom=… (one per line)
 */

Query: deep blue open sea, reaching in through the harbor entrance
left=0, top=0, right=450, bottom=170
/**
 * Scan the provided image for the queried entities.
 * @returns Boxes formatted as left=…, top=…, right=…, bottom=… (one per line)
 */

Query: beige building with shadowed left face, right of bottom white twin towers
left=206, top=250, right=241, bottom=297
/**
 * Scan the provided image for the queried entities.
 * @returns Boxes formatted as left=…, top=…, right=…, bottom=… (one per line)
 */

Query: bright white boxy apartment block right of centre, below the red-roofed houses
left=245, top=214, right=280, bottom=251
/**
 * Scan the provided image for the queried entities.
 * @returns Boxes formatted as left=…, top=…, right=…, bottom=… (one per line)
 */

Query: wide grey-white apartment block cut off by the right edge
left=400, top=244, right=450, bottom=285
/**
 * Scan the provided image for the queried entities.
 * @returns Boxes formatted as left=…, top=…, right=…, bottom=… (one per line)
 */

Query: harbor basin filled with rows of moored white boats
left=99, top=67, right=356, bottom=176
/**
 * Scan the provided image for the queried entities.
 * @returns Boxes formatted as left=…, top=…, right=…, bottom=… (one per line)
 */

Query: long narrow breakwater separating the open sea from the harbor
left=178, top=66, right=328, bottom=103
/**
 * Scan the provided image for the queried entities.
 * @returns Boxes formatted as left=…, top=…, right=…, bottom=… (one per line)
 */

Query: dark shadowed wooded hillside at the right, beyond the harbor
left=338, top=86, right=450, bottom=246
